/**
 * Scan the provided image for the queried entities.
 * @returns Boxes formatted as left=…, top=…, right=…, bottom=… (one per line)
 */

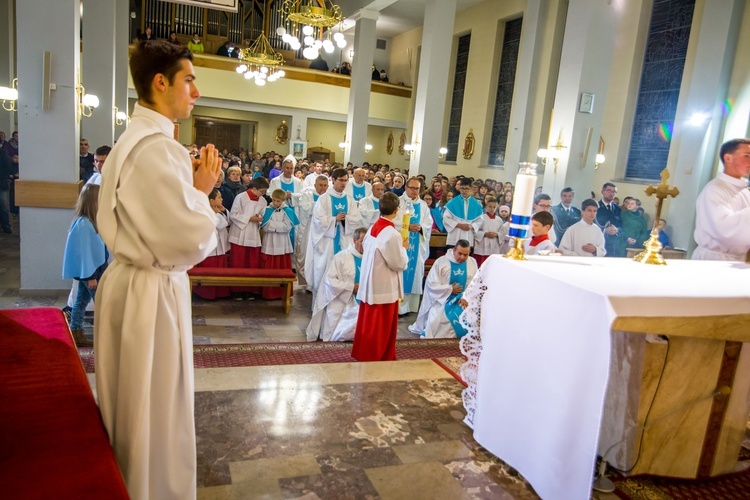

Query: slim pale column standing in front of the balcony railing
left=344, top=10, right=379, bottom=166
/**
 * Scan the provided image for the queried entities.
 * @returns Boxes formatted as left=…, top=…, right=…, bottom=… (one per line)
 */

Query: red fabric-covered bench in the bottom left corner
left=0, top=308, right=129, bottom=499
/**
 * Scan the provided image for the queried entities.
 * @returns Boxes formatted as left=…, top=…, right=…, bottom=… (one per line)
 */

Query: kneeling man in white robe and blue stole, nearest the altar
left=409, top=240, right=477, bottom=339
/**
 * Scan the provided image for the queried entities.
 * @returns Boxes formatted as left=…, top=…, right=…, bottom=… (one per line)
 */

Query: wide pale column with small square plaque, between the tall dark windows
left=538, top=0, right=619, bottom=201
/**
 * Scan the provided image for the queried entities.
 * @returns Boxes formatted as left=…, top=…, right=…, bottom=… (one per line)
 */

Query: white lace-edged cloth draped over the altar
left=461, top=256, right=750, bottom=499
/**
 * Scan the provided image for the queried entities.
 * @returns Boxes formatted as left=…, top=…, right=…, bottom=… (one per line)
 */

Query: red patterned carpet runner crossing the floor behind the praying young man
left=78, top=339, right=461, bottom=373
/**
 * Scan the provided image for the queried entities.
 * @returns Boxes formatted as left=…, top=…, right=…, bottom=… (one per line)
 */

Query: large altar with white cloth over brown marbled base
left=461, top=256, right=750, bottom=499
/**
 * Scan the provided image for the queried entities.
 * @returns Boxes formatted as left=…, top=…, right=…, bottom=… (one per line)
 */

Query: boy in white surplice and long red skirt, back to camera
left=352, top=193, right=409, bottom=361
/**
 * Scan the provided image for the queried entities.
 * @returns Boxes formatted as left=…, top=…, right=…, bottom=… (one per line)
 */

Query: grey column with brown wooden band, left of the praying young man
left=16, top=0, right=81, bottom=292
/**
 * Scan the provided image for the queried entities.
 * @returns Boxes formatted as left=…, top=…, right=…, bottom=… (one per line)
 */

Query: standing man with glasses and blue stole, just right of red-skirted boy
left=394, top=177, right=432, bottom=316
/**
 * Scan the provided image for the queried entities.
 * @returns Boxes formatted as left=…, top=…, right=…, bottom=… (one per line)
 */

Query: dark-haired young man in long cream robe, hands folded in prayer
left=94, top=42, right=221, bottom=500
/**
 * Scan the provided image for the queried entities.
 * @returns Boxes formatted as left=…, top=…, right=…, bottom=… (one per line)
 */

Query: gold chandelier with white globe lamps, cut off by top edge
left=276, top=0, right=346, bottom=59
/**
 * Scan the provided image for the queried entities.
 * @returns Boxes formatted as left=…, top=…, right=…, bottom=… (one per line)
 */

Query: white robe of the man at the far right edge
left=693, top=172, right=750, bottom=262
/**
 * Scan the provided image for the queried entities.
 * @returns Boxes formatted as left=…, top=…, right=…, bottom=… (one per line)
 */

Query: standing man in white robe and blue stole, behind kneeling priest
left=305, top=168, right=362, bottom=303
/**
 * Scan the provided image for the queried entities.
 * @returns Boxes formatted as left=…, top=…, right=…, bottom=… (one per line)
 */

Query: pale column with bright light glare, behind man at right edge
left=667, top=0, right=744, bottom=250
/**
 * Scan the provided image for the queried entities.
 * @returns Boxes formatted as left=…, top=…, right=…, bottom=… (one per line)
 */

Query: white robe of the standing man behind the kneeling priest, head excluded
left=305, top=187, right=362, bottom=294
